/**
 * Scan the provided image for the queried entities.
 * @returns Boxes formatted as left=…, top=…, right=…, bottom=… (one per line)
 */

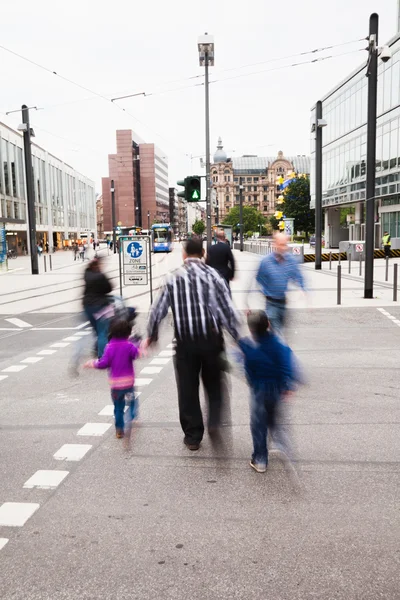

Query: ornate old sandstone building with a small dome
left=211, top=138, right=310, bottom=223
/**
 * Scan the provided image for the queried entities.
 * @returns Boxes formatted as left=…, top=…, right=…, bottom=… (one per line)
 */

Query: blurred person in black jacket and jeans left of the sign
left=83, top=258, right=112, bottom=358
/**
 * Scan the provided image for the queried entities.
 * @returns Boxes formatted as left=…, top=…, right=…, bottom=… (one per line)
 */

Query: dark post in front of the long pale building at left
left=21, top=104, right=39, bottom=275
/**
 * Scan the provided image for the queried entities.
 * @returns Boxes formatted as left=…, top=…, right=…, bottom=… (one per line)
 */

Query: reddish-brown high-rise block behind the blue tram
left=102, top=129, right=169, bottom=233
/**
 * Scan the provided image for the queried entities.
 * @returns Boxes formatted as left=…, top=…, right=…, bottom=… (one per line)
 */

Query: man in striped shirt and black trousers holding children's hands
left=147, top=239, right=239, bottom=450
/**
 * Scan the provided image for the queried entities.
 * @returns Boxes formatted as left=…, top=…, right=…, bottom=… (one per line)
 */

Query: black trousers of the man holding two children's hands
left=174, top=338, right=222, bottom=444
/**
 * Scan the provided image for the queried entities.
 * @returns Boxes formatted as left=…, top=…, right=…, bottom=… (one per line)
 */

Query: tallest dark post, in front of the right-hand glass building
left=364, top=13, right=379, bottom=298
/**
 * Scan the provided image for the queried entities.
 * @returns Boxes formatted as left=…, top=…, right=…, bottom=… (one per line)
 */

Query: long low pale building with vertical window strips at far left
left=0, top=123, right=96, bottom=254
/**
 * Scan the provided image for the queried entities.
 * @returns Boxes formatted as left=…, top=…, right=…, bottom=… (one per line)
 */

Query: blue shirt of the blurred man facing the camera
left=256, top=252, right=305, bottom=300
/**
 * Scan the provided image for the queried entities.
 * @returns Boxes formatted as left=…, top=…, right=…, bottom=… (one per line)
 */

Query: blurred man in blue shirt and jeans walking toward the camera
left=256, top=233, right=306, bottom=334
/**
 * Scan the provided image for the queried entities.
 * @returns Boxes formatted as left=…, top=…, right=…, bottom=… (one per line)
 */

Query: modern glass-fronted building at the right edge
left=311, top=29, right=400, bottom=248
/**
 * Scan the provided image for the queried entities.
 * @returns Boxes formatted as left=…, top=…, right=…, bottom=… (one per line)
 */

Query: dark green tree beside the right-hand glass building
left=282, top=176, right=315, bottom=237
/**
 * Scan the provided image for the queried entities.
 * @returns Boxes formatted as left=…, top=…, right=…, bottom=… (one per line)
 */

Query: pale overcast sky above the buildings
left=0, top=0, right=397, bottom=192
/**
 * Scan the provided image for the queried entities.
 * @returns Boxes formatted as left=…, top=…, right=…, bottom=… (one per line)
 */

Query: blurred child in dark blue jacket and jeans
left=238, top=310, right=299, bottom=473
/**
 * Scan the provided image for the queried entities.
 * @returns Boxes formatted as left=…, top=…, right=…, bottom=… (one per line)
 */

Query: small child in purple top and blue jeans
left=85, top=320, right=139, bottom=438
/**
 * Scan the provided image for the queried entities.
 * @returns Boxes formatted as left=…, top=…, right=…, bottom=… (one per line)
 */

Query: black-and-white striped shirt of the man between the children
left=147, top=258, right=239, bottom=341
